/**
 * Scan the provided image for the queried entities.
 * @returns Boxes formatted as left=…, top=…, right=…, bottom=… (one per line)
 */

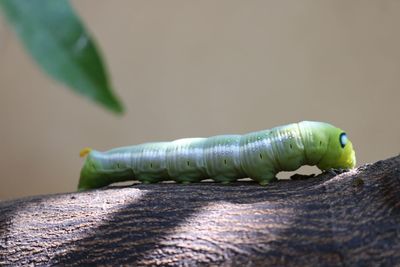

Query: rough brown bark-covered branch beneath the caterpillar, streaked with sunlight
left=0, top=156, right=400, bottom=266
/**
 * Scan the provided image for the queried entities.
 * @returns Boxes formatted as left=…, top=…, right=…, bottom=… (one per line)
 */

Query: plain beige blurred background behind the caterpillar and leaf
left=0, top=0, right=400, bottom=200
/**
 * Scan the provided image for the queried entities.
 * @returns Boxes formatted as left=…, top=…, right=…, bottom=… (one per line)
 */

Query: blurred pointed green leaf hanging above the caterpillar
left=0, top=0, right=123, bottom=113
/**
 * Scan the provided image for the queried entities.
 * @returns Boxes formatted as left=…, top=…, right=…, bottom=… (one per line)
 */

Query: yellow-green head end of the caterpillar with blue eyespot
left=317, top=127, right=356, bottom=170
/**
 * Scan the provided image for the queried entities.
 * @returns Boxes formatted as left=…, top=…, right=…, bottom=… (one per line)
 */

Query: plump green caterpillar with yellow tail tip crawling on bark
left=78, top=121, right=356, bottom=190
